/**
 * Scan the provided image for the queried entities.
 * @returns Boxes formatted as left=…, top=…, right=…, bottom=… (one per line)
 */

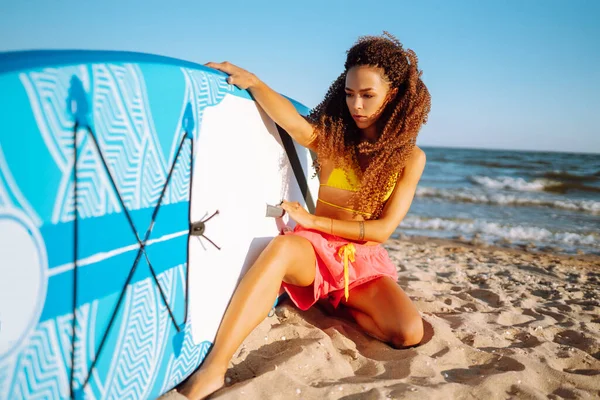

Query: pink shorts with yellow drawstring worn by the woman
left=281, top=225, right=398, bottom=310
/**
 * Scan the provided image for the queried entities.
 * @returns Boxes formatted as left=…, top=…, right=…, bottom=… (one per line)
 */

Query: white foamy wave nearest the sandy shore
left=400, top=217, right=600, bottom=248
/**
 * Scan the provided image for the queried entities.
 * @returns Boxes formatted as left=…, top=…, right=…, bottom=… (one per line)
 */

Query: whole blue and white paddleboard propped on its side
left=0, top=51, right=319, bottom=400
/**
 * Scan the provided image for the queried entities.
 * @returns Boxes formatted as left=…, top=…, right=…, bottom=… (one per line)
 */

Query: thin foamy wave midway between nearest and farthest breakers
left=416, top=187, right=600, bottom=215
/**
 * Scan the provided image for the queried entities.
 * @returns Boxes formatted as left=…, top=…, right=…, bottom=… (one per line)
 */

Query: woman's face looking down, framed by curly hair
left=346, top=65, right=390, bottom=129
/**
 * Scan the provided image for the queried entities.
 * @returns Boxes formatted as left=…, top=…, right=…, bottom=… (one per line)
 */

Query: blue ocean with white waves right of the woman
left=395, top=147, right=600, bottom=255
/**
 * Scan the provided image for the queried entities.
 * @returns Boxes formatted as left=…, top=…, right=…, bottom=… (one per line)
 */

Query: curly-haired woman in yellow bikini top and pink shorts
left=179, top=33, right=430, bottom=400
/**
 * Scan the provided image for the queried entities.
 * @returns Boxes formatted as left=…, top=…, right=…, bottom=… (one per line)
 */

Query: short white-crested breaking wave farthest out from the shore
left=468, top=175, right=600, bottom=194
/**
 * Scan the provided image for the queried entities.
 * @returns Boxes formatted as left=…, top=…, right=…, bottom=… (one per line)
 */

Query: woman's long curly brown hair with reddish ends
left=308, top=31, right=431, bottom=219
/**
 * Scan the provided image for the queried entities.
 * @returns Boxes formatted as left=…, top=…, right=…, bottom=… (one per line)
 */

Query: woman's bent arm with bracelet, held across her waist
left=296, top=147, right=426, bottom=243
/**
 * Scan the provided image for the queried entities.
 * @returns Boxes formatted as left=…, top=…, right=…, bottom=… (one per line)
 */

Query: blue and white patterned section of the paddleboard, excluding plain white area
left=0, top=51, right=307, bottom=399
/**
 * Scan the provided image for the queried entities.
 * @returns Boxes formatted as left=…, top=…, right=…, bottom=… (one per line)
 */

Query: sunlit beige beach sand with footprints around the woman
left=162, top=238, right=600, bottom=400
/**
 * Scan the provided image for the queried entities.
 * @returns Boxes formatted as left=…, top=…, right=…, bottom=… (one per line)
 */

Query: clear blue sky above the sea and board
left=0, top=0, right=600, bottom=153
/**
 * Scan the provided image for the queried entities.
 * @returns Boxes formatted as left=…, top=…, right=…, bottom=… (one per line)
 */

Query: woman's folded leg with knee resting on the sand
left=342, top=276, right=423, bottom=346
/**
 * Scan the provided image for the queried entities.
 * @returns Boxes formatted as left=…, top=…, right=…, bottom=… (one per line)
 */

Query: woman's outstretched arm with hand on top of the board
left=206, top=61, right=317, bottom=150
